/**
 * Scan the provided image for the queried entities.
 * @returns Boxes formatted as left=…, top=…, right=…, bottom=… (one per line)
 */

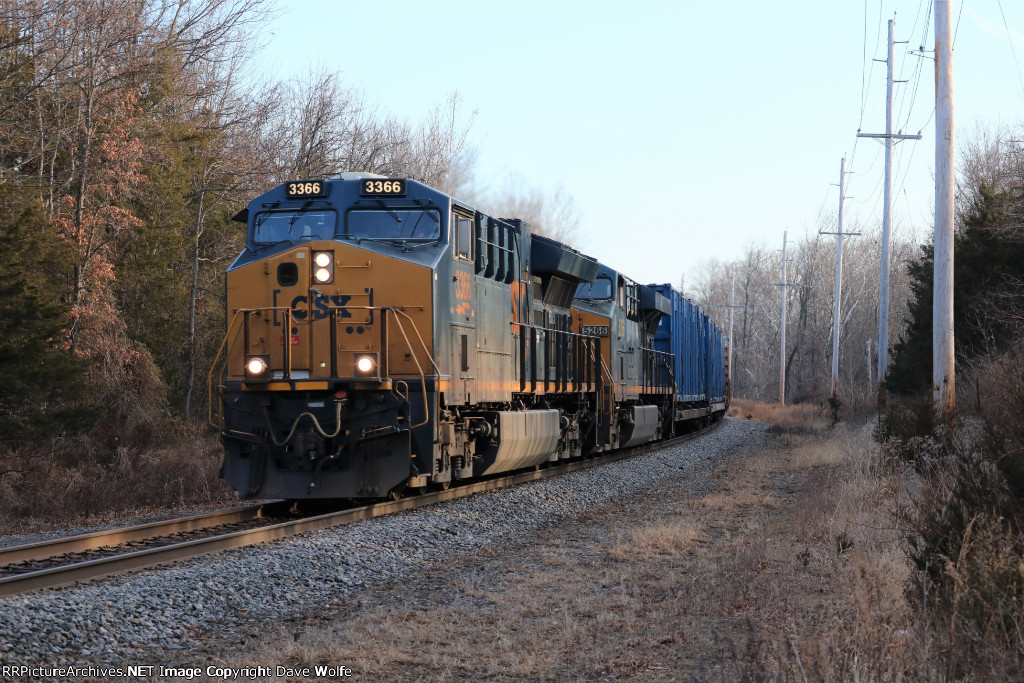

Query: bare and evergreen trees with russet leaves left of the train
left=0, top=0, right=487, bottom=514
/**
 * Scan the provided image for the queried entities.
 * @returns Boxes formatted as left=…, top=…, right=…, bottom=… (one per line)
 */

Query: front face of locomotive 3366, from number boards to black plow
left=214, top=178, right=446, bottom=499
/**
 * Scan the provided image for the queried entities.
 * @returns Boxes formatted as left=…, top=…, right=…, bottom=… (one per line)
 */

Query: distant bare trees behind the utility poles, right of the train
left=690, top=220, right=918, bottom=404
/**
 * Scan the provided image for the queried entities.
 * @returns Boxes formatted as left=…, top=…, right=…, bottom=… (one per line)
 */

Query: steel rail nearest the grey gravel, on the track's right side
left=0, top=422, right=721, bottom=595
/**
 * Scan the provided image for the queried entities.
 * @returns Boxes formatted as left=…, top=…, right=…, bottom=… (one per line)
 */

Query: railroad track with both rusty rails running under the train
left=0, top=422, right=721, bottom=595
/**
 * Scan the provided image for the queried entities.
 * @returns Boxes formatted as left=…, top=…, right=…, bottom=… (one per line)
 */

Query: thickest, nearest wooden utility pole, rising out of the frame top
left=932, top=0, right=956, bottom=424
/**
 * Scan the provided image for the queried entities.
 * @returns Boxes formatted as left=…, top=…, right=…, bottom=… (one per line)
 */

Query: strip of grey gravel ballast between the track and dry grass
left=0, top=419, right=766, bottom=679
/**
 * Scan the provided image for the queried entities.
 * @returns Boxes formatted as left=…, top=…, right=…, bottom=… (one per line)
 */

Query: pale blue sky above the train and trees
left=262, top=0, right=1024, bottom=286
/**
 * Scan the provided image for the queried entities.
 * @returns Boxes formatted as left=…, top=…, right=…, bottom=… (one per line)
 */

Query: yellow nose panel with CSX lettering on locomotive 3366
left=227, top=241, right=432, bottom=391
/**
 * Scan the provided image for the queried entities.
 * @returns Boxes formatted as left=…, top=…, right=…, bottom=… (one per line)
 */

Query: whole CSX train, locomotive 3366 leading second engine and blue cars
left=211, top=173, right=728, bottom=500
